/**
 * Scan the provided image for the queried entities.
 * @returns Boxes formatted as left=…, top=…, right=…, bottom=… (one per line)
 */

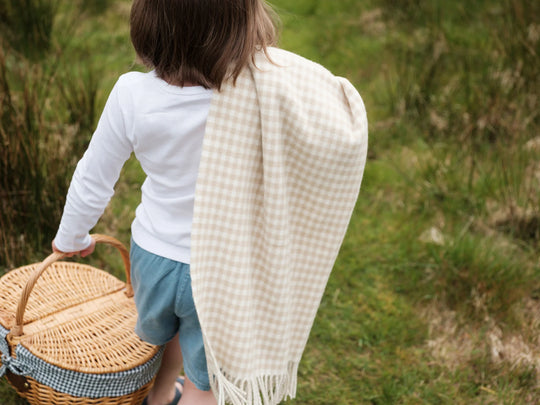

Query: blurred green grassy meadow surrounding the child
left=0, top=0, right=540, bottom=405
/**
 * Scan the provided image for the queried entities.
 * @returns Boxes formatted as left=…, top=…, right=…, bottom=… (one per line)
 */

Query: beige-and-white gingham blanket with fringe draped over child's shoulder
left=191, top=48, right=368, bottom=405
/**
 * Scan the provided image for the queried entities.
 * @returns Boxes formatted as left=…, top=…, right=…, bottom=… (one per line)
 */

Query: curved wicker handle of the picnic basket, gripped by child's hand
left=10, top=234, right=133, bottom=336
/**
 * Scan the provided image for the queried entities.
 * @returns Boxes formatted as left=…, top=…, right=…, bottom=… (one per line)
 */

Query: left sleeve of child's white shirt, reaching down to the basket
left=55, top=77, right=133, bottom=252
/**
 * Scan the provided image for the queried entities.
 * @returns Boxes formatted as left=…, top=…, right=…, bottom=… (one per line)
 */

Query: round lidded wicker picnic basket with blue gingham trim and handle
left=0, top=235, right=162, bottom=405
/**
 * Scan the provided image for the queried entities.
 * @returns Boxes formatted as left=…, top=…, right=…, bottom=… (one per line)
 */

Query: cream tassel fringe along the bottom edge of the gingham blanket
left=209, top=356, right=298, bottom=405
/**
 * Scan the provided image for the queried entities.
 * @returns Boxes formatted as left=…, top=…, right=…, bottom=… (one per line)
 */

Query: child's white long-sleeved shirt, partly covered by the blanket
left=55, top=71, right=212, bottom=263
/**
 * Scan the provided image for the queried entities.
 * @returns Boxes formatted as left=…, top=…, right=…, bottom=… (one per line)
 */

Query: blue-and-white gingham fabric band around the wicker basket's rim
left=0, top=326, right=163, bottom=398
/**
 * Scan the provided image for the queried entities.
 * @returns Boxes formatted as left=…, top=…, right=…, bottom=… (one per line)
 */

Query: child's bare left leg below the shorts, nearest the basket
left=147, top=334, right=182, bottom=405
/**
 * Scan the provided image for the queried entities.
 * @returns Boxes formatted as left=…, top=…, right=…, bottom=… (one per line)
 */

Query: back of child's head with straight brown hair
left=131, top=0, right=276, bottom=89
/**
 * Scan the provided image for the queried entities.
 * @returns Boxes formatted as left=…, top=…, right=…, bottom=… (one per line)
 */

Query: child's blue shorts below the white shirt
left=130, top=240, right=210, bottom=391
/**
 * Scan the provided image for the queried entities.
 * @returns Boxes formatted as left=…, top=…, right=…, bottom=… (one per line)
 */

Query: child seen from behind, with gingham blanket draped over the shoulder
left=53, top=0, right=367, bottom=405
